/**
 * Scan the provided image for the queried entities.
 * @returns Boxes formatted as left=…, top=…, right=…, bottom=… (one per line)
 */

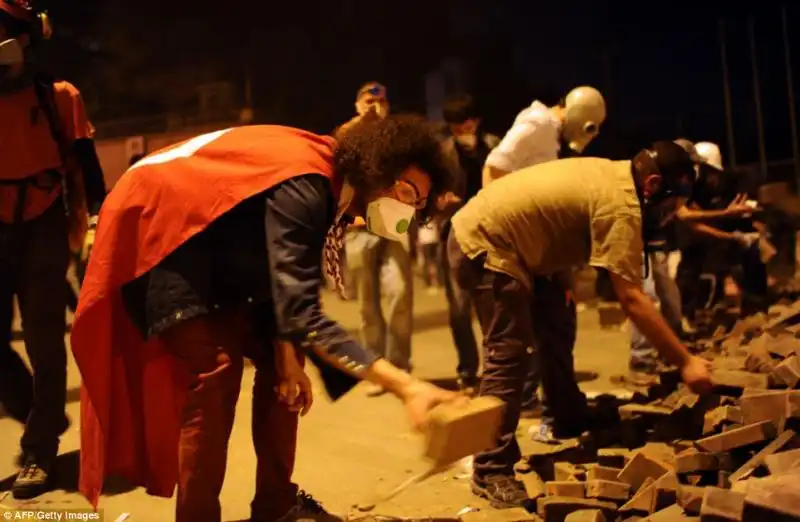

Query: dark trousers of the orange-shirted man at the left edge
left=0, top=200, right=70, bottom=460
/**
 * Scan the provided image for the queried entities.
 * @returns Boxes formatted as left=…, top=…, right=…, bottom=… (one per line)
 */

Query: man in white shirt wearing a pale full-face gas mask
left=484, top=86, right=606, bottom=426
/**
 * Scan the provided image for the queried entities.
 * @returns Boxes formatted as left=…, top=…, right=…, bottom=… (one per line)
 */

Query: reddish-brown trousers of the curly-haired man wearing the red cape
left=161, top=313, right=298, bottom=522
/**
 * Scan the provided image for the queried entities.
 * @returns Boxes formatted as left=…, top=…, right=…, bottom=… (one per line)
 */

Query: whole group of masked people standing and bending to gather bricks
left=0, top=0, right=780, bottom=522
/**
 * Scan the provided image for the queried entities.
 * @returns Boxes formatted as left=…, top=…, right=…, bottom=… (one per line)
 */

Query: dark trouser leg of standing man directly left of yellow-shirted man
left=439, top=224, right=480, bottom=379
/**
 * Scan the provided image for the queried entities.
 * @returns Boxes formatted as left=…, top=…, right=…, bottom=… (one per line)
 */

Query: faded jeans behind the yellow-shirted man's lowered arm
left=631, top=252, right=683, bottom=362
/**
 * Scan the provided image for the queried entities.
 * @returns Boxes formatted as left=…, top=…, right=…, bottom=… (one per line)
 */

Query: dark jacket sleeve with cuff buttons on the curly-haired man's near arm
left=265, top=174, right=378, bottom=374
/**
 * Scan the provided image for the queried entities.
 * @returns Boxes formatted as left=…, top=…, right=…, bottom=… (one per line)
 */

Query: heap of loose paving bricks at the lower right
left=518, top=300, right=800, bottom=522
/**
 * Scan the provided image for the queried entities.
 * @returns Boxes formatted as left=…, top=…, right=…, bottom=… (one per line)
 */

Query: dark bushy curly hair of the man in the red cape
left=333, top=113, right=453, bottom=218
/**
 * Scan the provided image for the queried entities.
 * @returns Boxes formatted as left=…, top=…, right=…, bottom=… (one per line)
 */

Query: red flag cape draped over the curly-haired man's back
left=71, top=126, right=341, bottom=507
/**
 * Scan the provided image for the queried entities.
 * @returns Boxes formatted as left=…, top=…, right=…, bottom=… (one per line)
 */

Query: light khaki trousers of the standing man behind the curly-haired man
left=347, top=230, right=414, bottom=370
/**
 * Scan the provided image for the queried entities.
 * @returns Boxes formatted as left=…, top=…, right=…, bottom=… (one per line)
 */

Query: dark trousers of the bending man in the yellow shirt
left=448, top=236, right=588, bottom=478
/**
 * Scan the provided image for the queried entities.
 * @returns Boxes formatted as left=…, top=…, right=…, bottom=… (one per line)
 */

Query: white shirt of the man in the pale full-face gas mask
left=486, top=100, right=561, bottom=172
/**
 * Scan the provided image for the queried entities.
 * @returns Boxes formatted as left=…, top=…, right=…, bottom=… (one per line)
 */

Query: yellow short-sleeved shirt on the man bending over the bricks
left=452, top=158, right=644, bottom=287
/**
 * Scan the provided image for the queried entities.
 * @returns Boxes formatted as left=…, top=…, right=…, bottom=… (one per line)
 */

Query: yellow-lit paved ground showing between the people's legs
left=0, top=288, right=627, bottom=522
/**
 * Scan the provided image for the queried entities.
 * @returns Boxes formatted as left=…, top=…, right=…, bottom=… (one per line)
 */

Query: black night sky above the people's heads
left=32, top=0, right=800, bottom=169
